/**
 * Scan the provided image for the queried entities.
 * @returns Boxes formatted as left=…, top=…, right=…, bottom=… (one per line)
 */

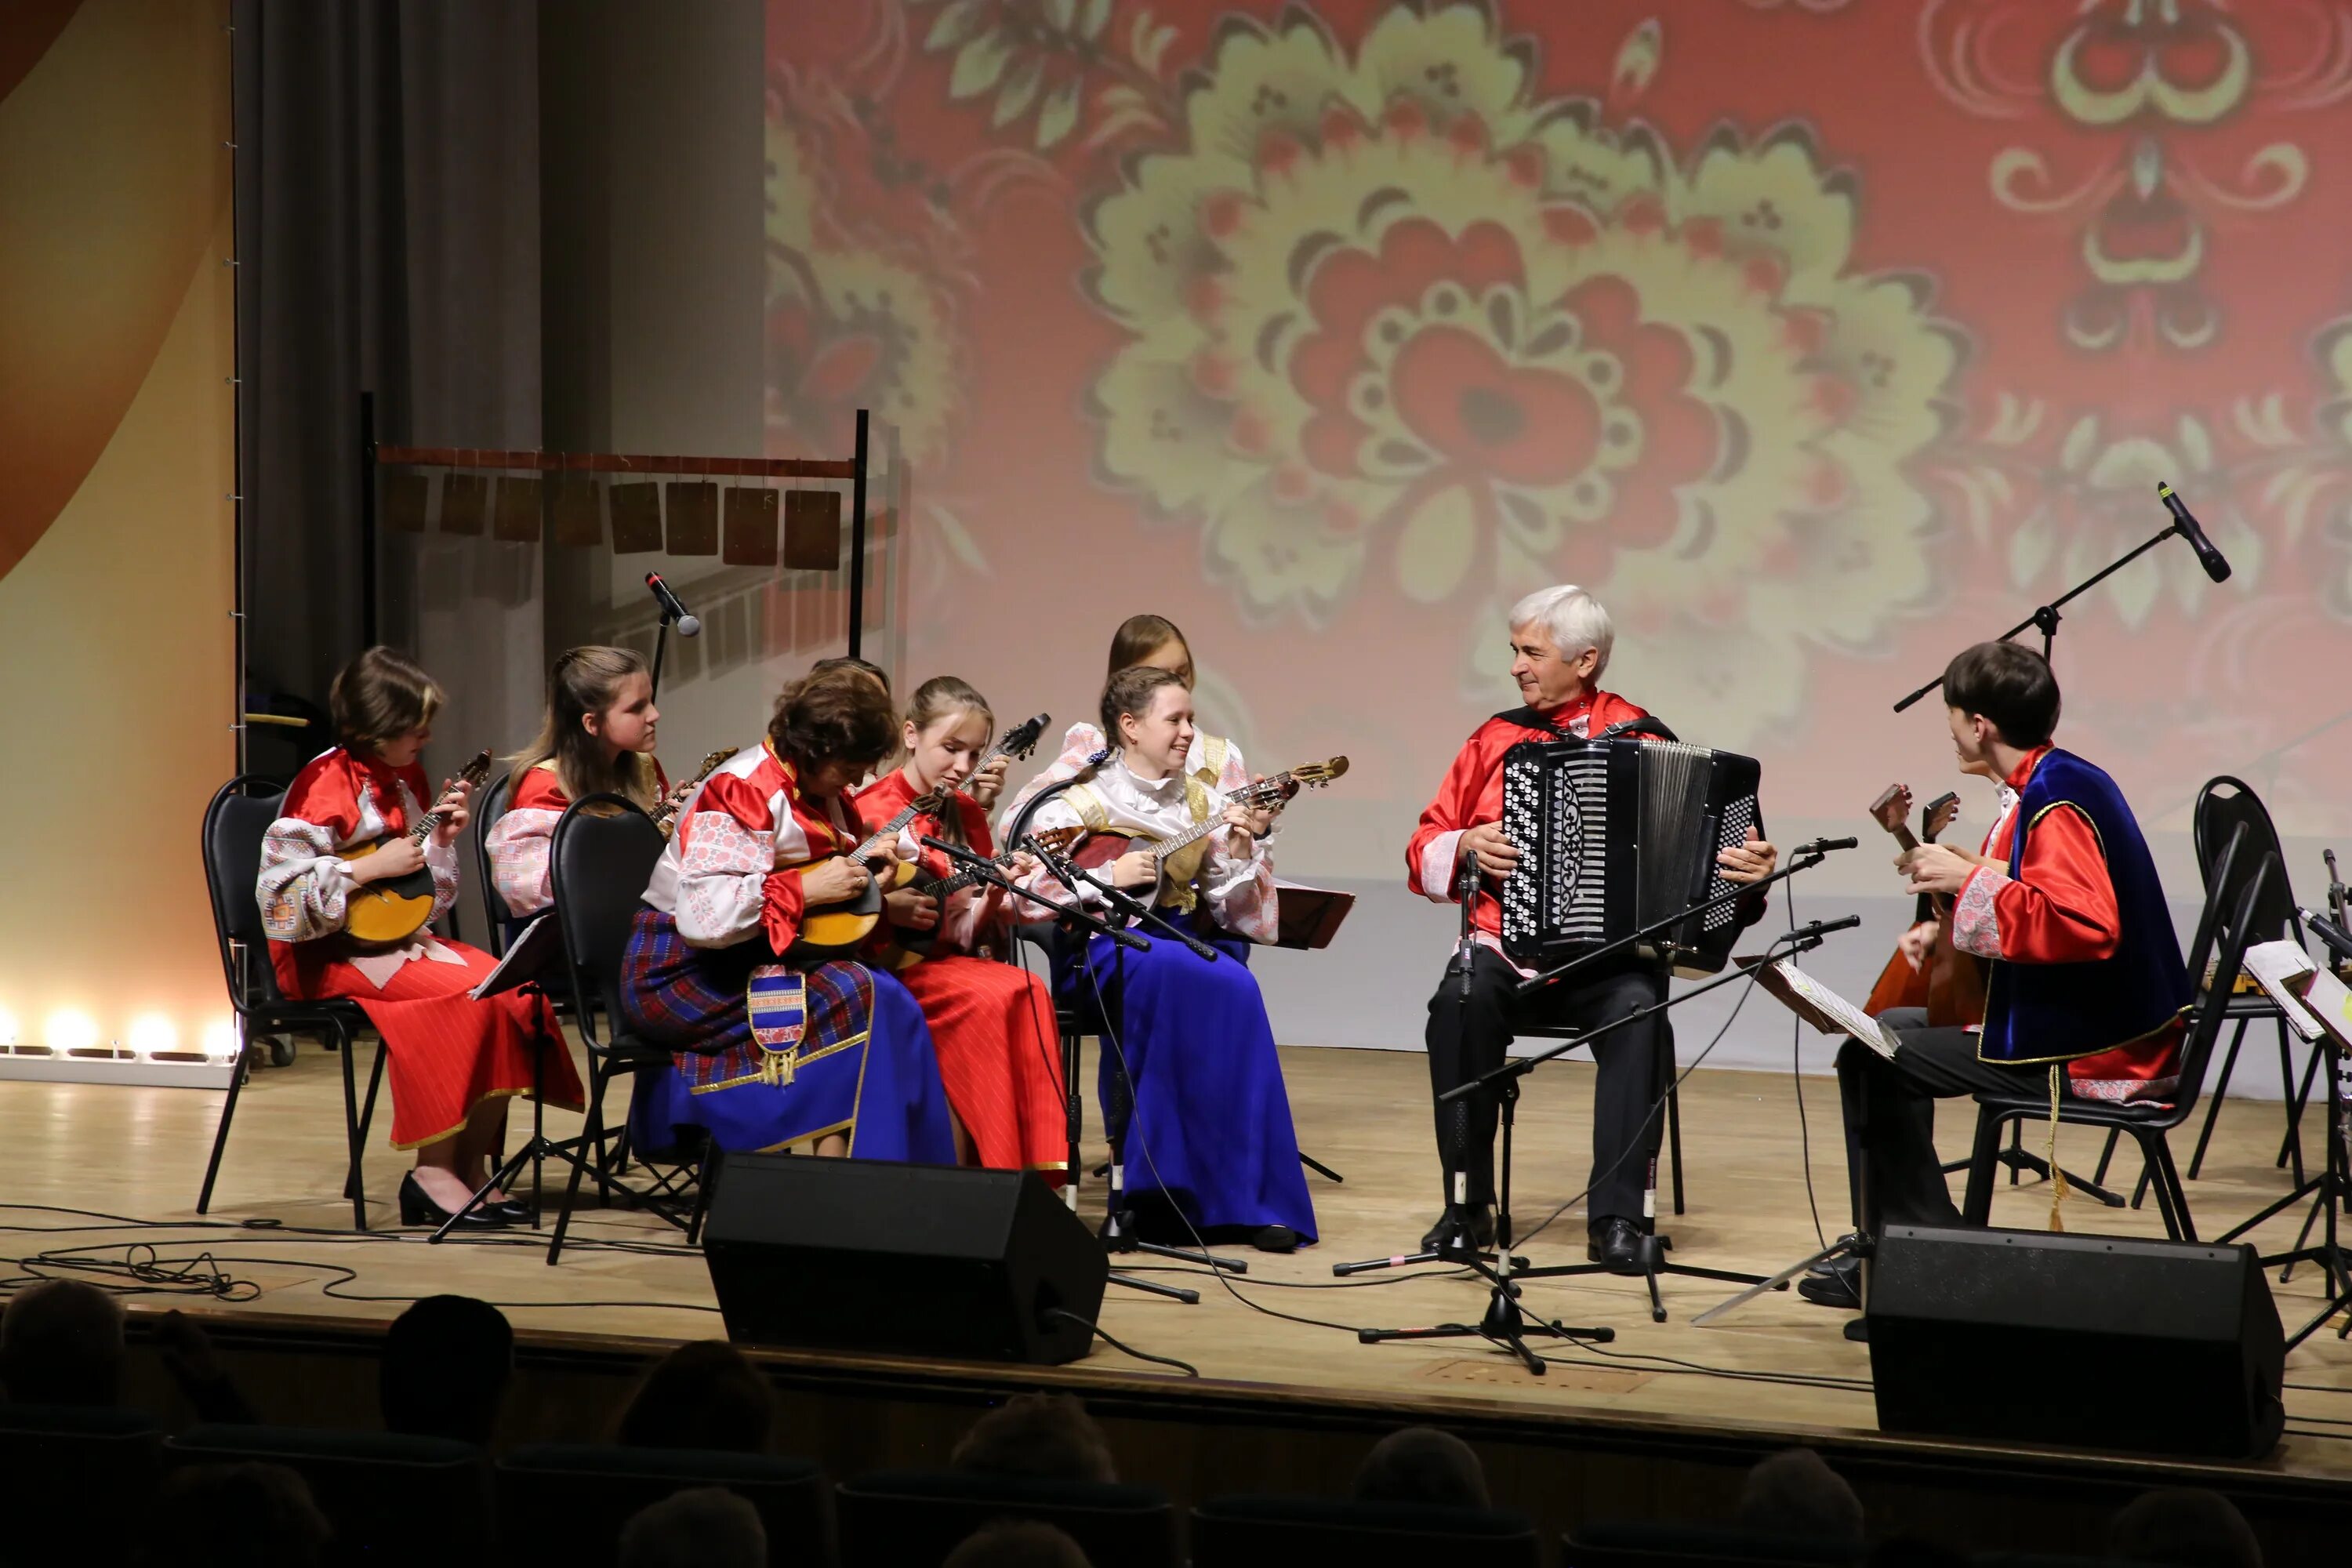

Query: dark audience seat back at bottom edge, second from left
left=165, top=1425, right=489, bottom=1563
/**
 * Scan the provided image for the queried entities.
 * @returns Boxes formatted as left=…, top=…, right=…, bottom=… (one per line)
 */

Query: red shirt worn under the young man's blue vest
left=1952, top=743, right=2187, bottom=1100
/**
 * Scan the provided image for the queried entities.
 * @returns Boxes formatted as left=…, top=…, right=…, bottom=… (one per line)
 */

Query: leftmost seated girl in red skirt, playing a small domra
left=256, top=649, right=581, bottom=1225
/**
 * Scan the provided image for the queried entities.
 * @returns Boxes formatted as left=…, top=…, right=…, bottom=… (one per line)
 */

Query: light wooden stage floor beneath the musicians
left=13, top=1044, right=2352, bottom=1479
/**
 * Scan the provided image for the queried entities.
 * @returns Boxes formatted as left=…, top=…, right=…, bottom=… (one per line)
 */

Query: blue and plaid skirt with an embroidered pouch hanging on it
left=621, top=907, right=955, bottom=1163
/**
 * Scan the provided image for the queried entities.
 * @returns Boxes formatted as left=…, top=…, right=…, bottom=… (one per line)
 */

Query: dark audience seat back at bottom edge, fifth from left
left=1192, top=1495, right=1543, bottom=1568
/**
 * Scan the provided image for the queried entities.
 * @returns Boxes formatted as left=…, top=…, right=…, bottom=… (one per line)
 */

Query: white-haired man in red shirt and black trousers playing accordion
left=1404, top=583, right=1776, bottom=1272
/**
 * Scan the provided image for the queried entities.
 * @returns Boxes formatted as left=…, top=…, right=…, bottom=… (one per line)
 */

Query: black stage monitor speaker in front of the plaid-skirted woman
left=703, top=1154, right=1110, bottom=1363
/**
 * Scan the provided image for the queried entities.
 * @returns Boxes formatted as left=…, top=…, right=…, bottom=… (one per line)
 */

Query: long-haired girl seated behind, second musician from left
left=485, top=647, right=670, bottom=921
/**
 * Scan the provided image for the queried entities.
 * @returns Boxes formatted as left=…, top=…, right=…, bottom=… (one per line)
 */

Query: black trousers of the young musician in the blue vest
left=1837, top=1006, right=2049, bottom=1236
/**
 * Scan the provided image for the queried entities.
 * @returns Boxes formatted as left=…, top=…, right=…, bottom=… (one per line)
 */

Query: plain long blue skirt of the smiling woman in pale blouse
left=1058, top=909, right=1315, bottom=1241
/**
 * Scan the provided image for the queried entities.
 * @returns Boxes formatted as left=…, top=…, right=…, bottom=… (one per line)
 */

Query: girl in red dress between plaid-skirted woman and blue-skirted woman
left=856, top=675, right=1070, bottom=1185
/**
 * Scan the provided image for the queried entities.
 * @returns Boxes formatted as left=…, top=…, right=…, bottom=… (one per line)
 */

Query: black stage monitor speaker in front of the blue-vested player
left=1867, top=1225, right=2286, bottom=1460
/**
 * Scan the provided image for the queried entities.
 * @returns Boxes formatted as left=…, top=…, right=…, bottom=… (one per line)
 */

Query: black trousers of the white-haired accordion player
left=1428, top=947, right=1665, bottom=1222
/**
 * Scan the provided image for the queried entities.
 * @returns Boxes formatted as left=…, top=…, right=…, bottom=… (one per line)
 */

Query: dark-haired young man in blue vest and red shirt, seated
left=1797, top=642, right=2190, bottom=1307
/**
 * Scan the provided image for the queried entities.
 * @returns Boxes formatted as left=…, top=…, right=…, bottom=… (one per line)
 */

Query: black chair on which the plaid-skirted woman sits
left=548, top=794, right=703, bottom=1265
